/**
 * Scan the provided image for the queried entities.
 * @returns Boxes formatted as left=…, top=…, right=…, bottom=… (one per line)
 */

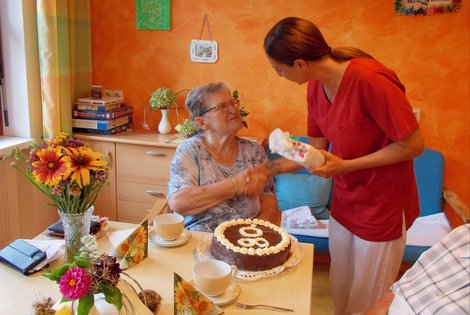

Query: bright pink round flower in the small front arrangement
left=59, top=266, right=93, bottom=300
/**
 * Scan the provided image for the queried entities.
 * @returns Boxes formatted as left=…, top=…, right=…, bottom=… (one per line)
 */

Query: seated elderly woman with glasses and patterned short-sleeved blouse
left=168, top=83, right=280, bottom=232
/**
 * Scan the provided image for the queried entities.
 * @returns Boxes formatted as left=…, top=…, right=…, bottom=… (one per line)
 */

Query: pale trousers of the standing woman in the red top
left=329, top=217, right=406, bottom=315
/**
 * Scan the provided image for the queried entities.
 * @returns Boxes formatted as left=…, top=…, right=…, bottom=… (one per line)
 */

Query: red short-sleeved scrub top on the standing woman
left=307, top=58, right=419, bottom=241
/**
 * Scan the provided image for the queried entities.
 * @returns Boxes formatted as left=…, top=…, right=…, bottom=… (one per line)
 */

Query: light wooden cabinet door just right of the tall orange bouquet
left=84, top=139, right=117, bottom=221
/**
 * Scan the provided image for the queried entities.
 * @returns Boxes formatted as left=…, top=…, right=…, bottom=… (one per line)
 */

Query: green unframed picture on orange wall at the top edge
left=135, top=0, right=171, bottom=30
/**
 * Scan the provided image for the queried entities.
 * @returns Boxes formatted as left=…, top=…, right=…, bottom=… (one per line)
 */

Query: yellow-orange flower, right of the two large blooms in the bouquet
left=62, top=147, right=108, bottom=188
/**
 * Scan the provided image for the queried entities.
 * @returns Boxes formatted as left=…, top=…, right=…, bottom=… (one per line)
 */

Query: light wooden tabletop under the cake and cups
left=0, top=222, right=313, bottom=315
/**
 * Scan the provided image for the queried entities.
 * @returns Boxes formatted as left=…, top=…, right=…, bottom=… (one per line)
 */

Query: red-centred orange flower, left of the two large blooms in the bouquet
left=31, top=148, right=71, bottom=186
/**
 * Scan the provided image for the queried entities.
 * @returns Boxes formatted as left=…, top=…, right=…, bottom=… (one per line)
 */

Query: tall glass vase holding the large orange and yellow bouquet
left=4, top=133, right=109, bottom=262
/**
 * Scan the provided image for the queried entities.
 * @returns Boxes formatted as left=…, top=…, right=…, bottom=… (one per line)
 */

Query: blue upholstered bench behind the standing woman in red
left=267, top=137, right=451, bottom=263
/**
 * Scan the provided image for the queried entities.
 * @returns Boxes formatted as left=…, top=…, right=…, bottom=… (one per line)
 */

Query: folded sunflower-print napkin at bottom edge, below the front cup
left=174, top=273, right=223, bottom=315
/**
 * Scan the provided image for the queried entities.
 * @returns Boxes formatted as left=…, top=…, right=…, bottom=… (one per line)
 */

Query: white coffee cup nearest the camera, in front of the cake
left=193, top=259, right=238, bottom=296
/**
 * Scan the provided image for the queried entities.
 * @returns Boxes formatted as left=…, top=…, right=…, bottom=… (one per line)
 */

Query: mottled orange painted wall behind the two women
left=91, top=0, right=470, bottom=210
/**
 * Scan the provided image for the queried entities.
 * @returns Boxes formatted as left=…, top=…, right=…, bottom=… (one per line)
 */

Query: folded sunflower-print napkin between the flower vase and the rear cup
left=110, top=219, right=148, bottom=270
